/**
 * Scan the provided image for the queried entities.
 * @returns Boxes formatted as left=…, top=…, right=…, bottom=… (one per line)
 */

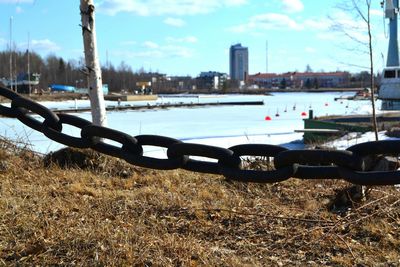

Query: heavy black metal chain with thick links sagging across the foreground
left=0, top=87, right=400, bottom=185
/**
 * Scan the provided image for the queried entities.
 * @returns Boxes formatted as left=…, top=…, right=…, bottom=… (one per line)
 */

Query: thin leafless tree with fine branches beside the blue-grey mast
left=331, top=0, right=378, bottom=140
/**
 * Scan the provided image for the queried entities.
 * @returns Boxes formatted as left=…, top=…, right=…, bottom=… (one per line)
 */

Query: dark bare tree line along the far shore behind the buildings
left=0, top=51, right=380, bottom=93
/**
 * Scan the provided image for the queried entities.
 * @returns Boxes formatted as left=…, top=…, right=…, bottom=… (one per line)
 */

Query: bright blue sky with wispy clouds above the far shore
left=0, top=0, right=388, bottom=76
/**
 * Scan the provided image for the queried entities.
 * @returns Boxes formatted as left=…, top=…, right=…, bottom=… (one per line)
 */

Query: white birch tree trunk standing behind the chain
left=80, top=0, right=107, bottom=126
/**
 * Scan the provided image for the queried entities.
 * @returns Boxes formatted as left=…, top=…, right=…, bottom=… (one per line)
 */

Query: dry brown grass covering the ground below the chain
left=0, top=141, right=400, bottom=266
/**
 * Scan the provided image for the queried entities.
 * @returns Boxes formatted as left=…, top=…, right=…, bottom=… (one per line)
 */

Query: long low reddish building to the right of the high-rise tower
left=249, top=71, right=350, bottom=89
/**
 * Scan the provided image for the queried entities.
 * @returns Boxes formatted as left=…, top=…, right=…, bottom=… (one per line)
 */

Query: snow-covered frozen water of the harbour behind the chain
left=0, top=92, right=380, bottom=155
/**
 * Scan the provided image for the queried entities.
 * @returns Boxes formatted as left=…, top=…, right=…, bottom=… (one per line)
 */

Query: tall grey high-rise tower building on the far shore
left=229, top=44, right=249, bottom=81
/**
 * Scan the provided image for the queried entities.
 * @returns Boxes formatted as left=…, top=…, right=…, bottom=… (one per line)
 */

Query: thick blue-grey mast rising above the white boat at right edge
left=385, top=0, right=400, bottom=67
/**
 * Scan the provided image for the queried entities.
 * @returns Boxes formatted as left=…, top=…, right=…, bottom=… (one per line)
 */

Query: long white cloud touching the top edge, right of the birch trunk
left=97, top=0, right=248, bottom=16
